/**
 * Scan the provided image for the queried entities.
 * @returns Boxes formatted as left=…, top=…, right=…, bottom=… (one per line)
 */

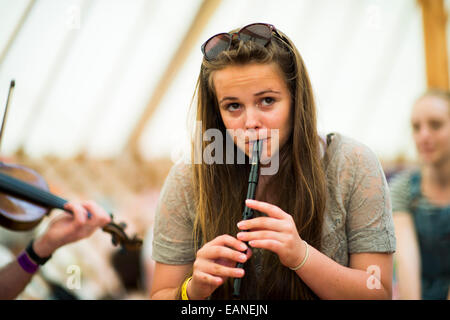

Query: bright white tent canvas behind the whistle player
left=0, top=0, right=450, bottom=160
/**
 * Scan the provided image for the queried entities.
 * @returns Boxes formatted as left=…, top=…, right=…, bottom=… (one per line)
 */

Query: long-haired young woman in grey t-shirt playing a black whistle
left=151, top=23, right=395, bottom=299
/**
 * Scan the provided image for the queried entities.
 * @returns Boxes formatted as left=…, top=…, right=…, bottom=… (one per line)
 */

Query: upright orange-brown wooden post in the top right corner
left=419, top=0, right=449, bottom=90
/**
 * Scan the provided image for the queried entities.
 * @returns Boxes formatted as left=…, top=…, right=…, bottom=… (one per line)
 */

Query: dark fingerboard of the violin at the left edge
left=0, top=172, right=67, bottom=210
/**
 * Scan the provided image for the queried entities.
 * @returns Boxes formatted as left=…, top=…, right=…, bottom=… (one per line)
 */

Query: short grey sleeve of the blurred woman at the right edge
left=389, top=172, right=411, bottom=214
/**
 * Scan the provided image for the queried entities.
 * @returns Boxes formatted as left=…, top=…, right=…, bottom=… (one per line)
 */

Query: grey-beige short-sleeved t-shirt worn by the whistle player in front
left=152, top=134, right=395, bottom=266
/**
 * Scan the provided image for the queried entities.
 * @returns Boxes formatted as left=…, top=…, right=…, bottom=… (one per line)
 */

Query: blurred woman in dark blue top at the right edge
left=391, top=90, right=450, bottom=299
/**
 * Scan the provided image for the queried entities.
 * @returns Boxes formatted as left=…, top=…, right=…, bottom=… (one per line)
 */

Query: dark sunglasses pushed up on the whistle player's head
left=202, top=23, right=282, bottom=61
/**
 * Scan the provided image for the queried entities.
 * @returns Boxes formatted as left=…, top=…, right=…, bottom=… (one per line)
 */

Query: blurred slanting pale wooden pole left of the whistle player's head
left=126, top=0, right=221, bottom=158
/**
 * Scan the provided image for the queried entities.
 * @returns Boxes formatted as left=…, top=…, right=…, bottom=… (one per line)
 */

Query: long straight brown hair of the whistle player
left=192, top=26, right=326, bottom=299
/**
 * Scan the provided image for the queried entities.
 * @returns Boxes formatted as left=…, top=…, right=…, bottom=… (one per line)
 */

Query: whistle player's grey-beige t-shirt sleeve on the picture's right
left=340, top=142, right=396, bottom=253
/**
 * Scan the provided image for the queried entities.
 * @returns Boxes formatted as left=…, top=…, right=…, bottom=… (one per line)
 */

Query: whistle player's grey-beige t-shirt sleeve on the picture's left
left=152, top=163, right=195, bottom=265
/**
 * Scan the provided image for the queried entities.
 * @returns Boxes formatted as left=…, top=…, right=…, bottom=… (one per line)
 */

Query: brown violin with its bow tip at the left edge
left=0, top=80, right=142, bottom=250
